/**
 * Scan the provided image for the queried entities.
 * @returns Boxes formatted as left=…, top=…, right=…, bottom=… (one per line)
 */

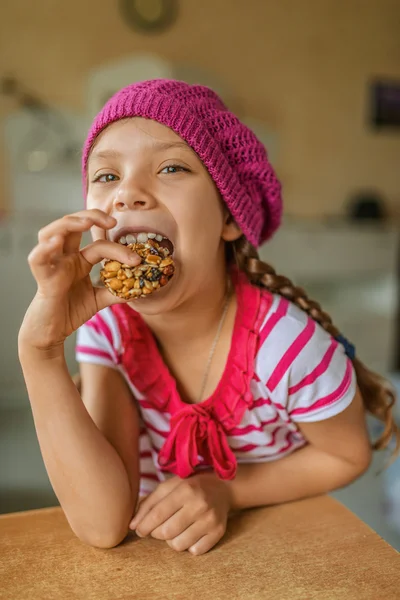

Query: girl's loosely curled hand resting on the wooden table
left=130, top=473, right=230, bottom=554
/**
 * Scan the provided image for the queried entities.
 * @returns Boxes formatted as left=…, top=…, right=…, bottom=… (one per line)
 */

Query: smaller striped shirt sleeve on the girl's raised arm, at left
left=75, top=308, right=121, bottom=369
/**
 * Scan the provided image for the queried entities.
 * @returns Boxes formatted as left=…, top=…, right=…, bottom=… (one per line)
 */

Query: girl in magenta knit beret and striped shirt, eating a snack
left=19, top=80, right=396, bottom=554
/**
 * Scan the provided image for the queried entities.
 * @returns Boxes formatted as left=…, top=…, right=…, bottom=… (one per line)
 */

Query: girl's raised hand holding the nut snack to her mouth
left=19, top=210, right=140, bottom=350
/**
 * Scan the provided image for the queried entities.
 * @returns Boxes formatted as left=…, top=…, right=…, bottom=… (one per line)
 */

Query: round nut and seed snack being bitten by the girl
left=100, top=238, right=175, bottom=300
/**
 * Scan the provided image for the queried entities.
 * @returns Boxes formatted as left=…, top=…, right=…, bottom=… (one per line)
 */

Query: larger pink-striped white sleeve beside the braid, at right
left=256, top=297, right=356, bottom=422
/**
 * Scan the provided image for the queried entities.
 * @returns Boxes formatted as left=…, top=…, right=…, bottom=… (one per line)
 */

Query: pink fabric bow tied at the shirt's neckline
left=158, top=404, right=237, bottom=479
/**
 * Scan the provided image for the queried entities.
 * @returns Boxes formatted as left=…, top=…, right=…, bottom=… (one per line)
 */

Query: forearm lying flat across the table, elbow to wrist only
left=227, top=445, right=365, bottom=510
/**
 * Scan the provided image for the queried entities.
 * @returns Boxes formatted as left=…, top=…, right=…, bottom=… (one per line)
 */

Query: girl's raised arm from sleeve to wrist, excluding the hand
left=20, top=345, right=139, bottom=548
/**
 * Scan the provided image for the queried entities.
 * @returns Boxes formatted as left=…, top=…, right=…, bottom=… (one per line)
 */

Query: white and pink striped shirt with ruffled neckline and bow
left=76, top=274, right=356, bottom=495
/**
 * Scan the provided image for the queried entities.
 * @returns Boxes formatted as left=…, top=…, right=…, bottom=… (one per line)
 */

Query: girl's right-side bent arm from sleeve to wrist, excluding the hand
left=226, top=391, right=371, bottom=510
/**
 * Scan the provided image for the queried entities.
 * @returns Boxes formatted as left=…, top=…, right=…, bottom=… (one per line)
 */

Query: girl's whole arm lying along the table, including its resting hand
left=130, top=392, right=371, bottom=554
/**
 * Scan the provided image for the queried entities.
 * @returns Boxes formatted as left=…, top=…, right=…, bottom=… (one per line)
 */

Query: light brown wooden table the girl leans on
left=0, top=496, right=400, bottom=600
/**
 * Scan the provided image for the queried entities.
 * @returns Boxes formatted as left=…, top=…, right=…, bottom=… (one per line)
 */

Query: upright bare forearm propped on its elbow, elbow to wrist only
left=20, top=348, right=137, bottom=546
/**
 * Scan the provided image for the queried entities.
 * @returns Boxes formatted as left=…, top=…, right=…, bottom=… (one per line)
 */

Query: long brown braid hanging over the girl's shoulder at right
left=227, top=237, right=400, bottom=455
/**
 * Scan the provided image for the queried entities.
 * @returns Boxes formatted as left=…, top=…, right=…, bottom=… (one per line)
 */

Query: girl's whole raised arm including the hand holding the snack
left=18, top=210, right=144, bottom=547
